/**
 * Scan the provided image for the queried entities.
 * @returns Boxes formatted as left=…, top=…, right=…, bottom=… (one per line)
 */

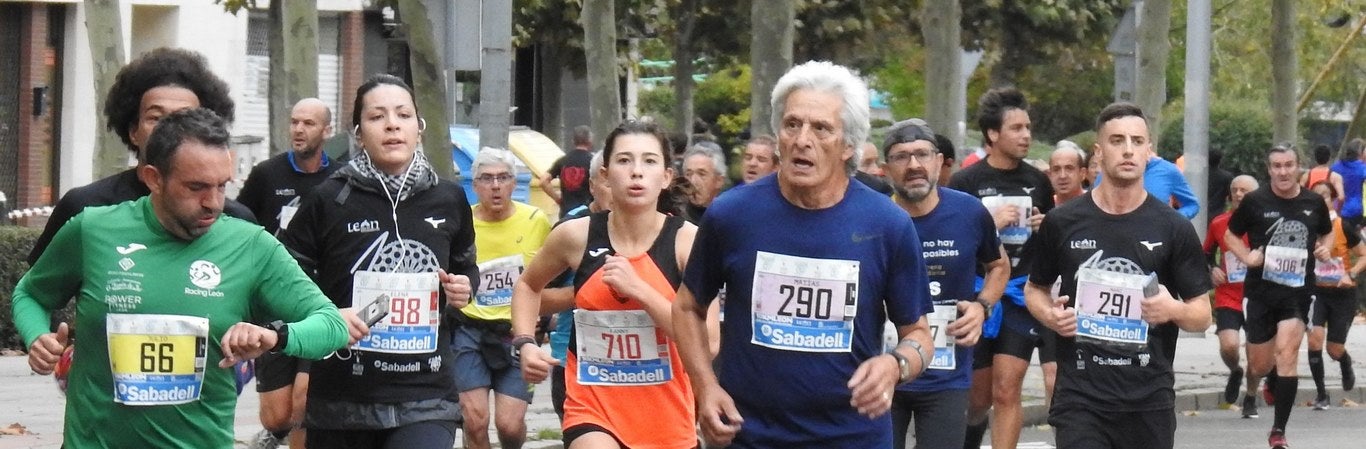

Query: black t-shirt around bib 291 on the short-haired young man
left=1030, top=192, right=1213, bottom=412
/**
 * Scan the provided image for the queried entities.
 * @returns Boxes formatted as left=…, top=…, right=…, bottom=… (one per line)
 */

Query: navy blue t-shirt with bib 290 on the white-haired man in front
left=683, top=176, right=932, bottom=449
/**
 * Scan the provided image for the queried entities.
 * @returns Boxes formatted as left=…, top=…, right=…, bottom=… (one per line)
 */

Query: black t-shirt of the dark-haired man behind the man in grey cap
left=948, top=160, right=1053, bottom=278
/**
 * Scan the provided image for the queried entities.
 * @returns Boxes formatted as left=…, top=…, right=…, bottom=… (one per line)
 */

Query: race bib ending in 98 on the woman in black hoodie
left=351, top=272, right=441, bottom=353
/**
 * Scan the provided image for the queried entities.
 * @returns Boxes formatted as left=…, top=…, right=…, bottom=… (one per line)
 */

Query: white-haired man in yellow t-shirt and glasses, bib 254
left=453, top=147, right=550, bottom=448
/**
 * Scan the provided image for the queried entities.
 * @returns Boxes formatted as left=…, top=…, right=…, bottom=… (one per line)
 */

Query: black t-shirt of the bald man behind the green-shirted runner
left=238, top=153, right=342, bottom=235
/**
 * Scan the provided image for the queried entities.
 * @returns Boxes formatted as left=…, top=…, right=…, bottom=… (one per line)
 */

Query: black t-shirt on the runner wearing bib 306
left=1228, top=186, right=1333, bottom=300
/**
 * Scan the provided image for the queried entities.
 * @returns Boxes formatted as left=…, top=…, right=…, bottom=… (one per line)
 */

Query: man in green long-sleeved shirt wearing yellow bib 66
left=14, top=108, right=365, bottom=449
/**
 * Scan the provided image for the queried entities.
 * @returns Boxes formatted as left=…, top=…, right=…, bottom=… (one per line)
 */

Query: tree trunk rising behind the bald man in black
left=268, top=0, right=318, bottom=154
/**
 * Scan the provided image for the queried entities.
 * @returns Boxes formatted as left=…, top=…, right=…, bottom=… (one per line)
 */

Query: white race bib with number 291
left=1076, top=269, right=1149, bottom=345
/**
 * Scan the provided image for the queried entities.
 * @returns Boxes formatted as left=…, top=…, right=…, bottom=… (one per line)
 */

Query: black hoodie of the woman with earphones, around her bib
left=280, top=165, right=478, bottom=403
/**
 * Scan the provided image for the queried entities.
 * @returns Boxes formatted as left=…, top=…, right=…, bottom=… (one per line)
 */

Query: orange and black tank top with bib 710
left=563, top=213, right=697, bottom=449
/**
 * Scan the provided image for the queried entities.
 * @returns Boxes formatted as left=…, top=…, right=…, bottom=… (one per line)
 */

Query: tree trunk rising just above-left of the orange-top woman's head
left=579, top=0, right=622, bottom=147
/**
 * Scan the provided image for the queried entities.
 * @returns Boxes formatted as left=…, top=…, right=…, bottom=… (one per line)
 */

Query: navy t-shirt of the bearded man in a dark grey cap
left=897, top=187, right=1001, bottom=392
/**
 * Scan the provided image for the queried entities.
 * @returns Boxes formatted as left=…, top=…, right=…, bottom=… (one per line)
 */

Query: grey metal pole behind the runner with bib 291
left=1183, top=0, right=1223, bottom=237
